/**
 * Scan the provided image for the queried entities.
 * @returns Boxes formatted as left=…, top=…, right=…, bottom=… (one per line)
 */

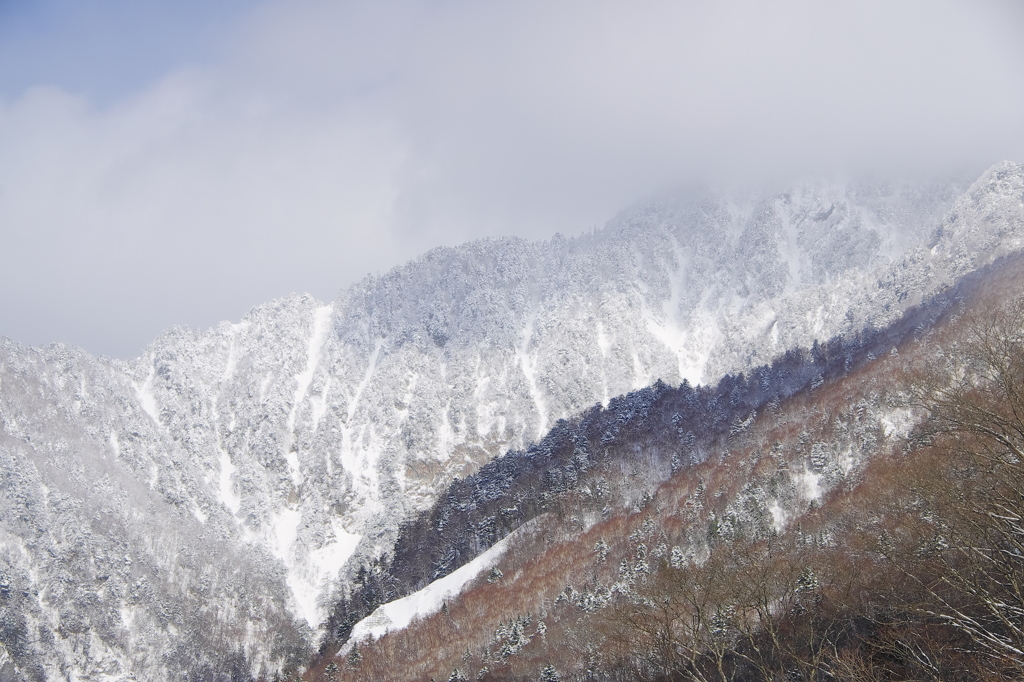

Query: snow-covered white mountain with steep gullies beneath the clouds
left=0, top=163, right=1024, bottom=679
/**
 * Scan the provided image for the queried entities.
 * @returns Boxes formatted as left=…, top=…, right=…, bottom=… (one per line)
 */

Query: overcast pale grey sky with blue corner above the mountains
left=6, top=0, right=1024, bottom=357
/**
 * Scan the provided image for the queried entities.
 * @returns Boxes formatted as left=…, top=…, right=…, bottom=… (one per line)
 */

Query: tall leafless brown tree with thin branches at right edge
left=908, top=300, right=1024, bottom=675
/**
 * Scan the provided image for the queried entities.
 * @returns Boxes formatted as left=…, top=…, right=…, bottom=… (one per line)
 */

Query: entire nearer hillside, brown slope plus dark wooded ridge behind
left=306, top=255, right=1024, bottom=680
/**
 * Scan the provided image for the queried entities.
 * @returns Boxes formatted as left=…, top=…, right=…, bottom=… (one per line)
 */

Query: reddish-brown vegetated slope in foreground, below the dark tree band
left=307, top=258, right=1024, bottom=682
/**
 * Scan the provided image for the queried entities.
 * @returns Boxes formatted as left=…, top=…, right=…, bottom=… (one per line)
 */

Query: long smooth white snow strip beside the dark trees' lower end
left=348, top=536, right=511, bottom=643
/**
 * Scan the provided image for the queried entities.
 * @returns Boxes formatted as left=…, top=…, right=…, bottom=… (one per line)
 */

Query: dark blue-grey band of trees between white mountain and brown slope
left=324, top=248, right=1003, bottom=652
